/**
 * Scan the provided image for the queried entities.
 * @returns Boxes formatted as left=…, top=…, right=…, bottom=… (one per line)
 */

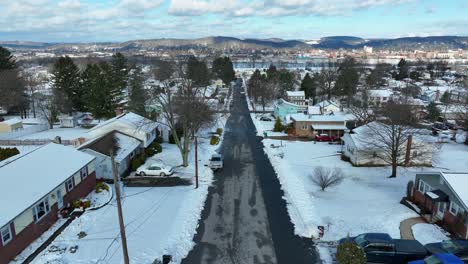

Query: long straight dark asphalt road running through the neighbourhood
left=182, top=81, right=319, bottom=264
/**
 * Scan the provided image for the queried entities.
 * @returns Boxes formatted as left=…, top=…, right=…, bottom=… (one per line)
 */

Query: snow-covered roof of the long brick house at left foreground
left=0, top=143, right=94, bottom=227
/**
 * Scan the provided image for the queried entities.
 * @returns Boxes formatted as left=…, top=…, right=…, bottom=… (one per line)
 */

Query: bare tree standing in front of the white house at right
left=362, top=102, right=417, bottom=178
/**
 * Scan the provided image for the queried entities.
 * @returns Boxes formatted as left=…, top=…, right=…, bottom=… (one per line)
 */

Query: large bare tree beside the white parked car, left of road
left=152, top=61, right=213, bottom=167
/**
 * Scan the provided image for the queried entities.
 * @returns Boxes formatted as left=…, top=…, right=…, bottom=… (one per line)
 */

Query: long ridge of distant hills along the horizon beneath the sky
left=0, top=36, right=468, bottom=51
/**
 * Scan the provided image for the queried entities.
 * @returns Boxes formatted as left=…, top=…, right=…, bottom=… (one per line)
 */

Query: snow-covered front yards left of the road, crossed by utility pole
left=20, top=117, right=226, bottom=264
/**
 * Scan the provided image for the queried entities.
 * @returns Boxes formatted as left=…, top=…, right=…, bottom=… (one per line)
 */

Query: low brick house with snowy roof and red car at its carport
left=290, top=113, right=347, bottom=137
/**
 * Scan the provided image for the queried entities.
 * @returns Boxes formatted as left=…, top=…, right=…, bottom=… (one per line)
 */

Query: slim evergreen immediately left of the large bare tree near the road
left=128, top=67, right=147, bottom=116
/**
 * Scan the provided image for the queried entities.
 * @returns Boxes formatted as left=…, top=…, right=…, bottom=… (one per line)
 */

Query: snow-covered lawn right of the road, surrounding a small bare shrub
left=263, top=139, right=468, bottom=241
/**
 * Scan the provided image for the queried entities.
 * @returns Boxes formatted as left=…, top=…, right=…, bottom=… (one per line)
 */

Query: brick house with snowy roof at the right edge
left=412, top=172, right=468, bottom=239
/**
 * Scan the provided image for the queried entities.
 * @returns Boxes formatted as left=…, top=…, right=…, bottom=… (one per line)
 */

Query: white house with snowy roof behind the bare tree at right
left=341, top=122, right=433, bottom=166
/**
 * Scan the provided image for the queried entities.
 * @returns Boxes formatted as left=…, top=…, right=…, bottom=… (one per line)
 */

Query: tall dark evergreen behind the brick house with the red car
left=335, top=57, right=359, bottom=107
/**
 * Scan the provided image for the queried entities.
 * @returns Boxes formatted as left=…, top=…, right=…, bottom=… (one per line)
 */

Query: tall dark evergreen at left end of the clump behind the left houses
left=52, top=56, right=84, bottom=113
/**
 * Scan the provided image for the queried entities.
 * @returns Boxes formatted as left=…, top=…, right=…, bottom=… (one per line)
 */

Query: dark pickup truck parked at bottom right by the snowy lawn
left=339, top=233, right=427, bottom=264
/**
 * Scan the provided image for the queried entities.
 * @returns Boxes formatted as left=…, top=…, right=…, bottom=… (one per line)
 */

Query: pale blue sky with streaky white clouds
left=0, top=0, right=468, bottom=42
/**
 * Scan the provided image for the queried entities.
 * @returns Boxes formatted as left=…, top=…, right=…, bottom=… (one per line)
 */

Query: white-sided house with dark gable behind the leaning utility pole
left=79, top=131, right=143, bottom=180
